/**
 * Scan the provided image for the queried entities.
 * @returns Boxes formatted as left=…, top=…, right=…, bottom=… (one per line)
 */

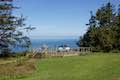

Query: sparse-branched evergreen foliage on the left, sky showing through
left=0, top=0, right=33, bottom=54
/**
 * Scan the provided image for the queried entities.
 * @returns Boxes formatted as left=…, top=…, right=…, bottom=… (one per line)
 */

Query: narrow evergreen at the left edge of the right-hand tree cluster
left=77, top=11, right=97, bottom=47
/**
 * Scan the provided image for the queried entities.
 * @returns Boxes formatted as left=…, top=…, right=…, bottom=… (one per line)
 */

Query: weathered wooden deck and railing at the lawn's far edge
left=30, top=47, right=92, bottom=56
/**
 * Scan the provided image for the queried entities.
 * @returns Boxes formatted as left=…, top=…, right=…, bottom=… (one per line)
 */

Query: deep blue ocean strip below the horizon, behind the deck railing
left=32, top=39, right=78, bottom=48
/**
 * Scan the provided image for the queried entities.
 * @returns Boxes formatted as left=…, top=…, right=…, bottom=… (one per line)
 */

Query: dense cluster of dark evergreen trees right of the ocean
left=77, top=2, right=120, bottom=52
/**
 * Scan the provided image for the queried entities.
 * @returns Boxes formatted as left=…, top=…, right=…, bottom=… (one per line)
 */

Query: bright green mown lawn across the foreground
left=0, top=54, right=120, bottom=80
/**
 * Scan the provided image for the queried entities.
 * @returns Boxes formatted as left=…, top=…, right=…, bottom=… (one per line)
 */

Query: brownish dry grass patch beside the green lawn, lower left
left=0, top=59, right=36, bottom=76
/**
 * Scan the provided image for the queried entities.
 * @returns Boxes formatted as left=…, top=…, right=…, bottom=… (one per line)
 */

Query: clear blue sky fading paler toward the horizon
left=15, top=0, right=120, bottom=39
